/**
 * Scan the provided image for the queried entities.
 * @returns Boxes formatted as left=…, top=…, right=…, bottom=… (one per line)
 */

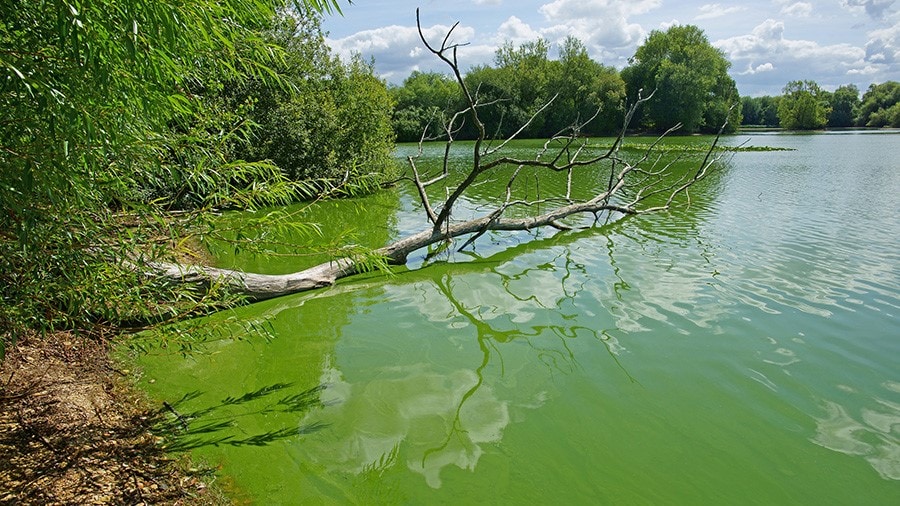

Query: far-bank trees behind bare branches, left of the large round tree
left=391, top=37, right=625, bottom=141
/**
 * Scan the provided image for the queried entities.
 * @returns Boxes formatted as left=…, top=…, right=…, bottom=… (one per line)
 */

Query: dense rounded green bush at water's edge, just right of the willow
left=223, top=11, right=394, bottom=191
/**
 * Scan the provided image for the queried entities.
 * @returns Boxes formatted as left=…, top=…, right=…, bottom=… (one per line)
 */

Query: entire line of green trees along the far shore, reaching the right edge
left=389, top=25, right=900, bottom=142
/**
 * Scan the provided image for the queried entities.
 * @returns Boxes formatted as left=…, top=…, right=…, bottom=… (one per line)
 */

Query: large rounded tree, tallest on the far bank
left=622, top=25, right=741, bottom=133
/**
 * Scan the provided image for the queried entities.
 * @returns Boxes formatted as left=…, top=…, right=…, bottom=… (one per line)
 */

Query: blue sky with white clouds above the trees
left=323, top=0, right=900, bottom=96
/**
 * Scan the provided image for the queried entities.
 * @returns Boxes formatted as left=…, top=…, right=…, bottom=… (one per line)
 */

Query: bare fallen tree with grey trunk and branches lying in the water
left=152, top=10, right=725, bottom=300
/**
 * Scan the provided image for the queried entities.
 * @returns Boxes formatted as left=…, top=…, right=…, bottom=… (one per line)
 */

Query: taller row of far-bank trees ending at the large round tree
left=390, top=25, right=740, bottom=141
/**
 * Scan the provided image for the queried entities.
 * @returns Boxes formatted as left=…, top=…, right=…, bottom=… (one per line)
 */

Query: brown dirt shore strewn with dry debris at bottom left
left=0, top=333, right=227, bottom=505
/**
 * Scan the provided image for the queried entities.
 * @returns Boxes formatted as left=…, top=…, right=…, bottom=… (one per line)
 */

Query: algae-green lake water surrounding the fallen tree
left=139, top=133, right=900, bottom=504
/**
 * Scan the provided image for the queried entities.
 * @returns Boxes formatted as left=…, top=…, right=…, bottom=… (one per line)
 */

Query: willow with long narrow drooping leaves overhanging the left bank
left=0, top=0, right=348, bottom=355
